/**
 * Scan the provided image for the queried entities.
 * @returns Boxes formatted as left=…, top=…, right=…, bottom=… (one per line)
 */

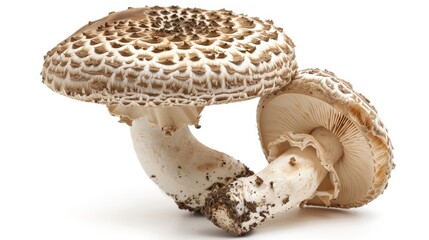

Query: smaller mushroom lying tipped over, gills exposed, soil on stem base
left=205, top=69, right=394, bottom=235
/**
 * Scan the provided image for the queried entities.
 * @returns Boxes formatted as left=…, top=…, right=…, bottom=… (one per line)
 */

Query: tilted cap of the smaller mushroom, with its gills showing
left=257, top=69, right=394, bottom=208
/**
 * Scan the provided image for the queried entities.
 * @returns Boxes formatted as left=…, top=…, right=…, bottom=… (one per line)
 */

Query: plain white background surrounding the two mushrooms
left=0, top=0, right=429, bottom=240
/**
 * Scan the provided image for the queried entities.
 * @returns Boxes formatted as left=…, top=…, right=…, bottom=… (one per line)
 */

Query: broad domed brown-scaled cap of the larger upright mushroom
left=42, top=6, right=297, bottom=106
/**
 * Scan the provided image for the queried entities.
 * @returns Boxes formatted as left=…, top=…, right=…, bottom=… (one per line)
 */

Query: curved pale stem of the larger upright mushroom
left=131, top=117, right=253, bottom=211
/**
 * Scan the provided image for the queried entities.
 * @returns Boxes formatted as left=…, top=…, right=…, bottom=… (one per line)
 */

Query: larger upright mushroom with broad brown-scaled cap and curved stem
left=42, top=6, right=297, bottom=211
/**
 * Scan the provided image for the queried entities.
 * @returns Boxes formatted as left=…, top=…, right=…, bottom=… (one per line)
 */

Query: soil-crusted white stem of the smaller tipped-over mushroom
left=204, top=127, right=343, bottom=236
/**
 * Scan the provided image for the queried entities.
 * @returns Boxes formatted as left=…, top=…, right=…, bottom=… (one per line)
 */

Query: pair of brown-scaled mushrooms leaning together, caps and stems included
left=42, top=6, right=392, bottom=235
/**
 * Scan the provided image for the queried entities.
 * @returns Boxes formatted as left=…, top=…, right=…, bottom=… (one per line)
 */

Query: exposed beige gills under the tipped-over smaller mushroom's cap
left=259, top=93, right=376, bottom=204
